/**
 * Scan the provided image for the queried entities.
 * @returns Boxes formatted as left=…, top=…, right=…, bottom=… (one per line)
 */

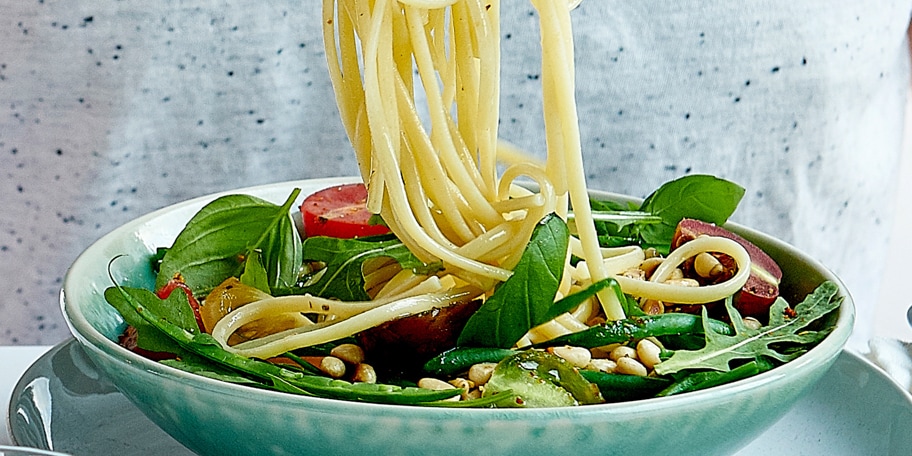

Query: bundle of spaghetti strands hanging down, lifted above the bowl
left=323, top=0, right=623, bottom=318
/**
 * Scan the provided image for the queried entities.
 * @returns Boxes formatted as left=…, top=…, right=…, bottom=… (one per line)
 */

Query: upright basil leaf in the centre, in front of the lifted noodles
left=457, top=214, right=570, bottom=348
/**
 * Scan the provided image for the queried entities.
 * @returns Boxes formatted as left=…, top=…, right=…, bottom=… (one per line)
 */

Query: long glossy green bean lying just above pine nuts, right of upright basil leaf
left=536, top=313, right=734, bottom=348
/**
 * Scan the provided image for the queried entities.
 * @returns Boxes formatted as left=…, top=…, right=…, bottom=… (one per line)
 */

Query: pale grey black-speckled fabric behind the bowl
left=0, top=0, right=910, bottom=350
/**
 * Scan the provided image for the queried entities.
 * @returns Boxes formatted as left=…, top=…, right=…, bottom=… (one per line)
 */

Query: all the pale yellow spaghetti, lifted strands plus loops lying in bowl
left=213, top=0, right=750, bottom=356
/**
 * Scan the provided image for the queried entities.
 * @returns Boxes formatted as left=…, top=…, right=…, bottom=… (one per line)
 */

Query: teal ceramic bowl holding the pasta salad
left=61, top=178, right=854, bottom=456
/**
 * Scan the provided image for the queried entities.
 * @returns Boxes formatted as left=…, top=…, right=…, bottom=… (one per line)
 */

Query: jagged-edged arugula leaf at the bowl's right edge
left=655, top=281, right=843, bottom=375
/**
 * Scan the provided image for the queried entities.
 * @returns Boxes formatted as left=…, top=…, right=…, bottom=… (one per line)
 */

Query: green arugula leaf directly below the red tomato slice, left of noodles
left=295, top=236, right=425, bottom=301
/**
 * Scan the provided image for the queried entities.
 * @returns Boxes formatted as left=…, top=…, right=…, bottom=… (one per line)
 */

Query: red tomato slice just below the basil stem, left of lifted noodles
left=301, top=184, right=390, bottom=239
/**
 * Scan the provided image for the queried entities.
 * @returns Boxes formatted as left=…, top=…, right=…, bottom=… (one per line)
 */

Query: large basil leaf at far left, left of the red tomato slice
left=156, top=189, right=302, bottom=295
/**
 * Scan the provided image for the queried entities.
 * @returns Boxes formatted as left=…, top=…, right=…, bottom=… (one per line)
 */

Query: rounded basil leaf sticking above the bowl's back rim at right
left=640, top=174, right=744, bottom=244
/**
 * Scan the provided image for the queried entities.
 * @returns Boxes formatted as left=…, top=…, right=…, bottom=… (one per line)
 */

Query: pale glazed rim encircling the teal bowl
left=59, top=177, right=855, bottom=419
